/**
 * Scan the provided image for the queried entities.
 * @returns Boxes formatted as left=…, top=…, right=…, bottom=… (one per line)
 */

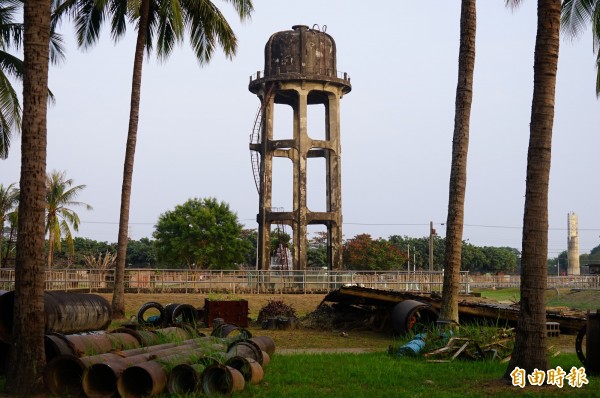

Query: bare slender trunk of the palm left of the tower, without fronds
left=112, top=0, right=150, bottom=319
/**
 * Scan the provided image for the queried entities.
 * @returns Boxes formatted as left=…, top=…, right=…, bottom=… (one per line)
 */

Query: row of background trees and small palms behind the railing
left=0, top=186, right=600, bottom=275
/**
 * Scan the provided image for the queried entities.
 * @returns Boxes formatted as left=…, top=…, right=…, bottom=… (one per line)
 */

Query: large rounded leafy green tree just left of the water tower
left=153, top=198, right=250, bottom=269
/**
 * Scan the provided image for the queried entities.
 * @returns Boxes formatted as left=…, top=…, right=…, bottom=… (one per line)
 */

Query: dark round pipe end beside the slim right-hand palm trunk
left=392, top=300, right=438, bottom=334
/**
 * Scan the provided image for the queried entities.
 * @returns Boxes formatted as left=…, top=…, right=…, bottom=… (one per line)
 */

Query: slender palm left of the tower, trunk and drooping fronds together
left=57, top=0, right=253, bottom=319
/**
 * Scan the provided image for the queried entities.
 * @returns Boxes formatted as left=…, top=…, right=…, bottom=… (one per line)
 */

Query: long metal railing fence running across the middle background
left=0, top=268, right=600, bottom=294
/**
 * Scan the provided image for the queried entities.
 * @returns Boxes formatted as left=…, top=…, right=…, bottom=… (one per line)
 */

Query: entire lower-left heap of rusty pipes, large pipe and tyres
left=0, top=292, right=275, bottom=397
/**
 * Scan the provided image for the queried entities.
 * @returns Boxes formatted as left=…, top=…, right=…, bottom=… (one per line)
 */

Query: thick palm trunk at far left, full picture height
left=5, top=0, right=50, bottom=397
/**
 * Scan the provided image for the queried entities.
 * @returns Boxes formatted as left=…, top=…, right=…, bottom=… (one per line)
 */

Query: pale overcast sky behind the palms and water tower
left=0, top=0, right=600, bottom=257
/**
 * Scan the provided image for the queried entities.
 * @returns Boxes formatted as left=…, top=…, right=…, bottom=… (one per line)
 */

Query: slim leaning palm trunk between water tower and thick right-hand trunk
left=440, top=0, right=477, bottom=324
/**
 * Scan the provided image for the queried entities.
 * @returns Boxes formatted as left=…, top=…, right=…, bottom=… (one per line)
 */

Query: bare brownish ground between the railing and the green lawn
left=96, top=293, right=575, bottom=353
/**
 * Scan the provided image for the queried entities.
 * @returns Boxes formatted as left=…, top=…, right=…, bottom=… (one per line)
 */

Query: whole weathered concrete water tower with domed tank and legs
left=248, top=25, right=352, bottom=270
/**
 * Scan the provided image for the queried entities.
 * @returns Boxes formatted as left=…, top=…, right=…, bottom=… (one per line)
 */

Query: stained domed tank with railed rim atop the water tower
left=249, top=25, right=352, bottom=93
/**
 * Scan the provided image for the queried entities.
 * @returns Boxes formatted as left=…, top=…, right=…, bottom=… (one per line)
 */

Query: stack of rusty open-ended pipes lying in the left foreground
left=44, top=336, right=275, bottom=397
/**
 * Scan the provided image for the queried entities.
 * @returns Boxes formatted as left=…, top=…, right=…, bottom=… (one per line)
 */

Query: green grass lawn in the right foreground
left=238, top=353, right=600, bottom=398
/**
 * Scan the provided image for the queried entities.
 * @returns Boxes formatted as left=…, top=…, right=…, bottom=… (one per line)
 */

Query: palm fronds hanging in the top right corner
left=560, top=0, right=600, bottom=92
